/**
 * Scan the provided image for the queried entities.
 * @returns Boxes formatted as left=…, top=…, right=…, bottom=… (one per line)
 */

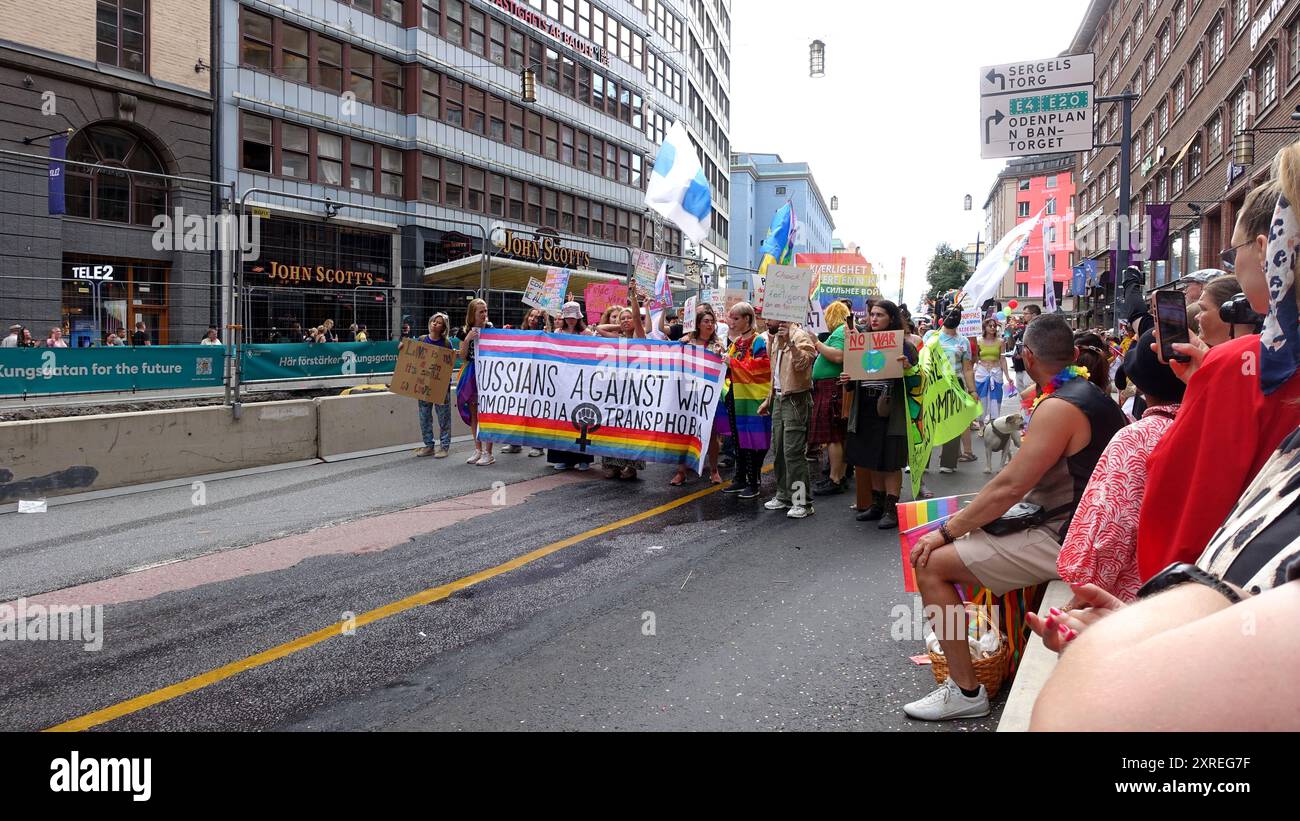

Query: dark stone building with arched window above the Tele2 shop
left=0, top=0, right=217, bottom=346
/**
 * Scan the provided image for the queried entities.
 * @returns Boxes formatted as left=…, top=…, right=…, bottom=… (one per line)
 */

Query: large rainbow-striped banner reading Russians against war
left=475, top=330, right=727, bottom=473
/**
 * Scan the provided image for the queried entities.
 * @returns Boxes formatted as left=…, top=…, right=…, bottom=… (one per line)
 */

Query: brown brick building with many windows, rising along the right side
left=1069, top=0, right=1300, bottom=322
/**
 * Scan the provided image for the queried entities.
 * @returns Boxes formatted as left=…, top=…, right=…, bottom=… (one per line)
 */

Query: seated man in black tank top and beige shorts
left=904, top=314, right=1126, bottom=721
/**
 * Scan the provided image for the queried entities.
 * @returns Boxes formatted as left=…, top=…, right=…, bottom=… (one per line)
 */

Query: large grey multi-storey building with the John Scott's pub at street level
left=221, top=0, right=731, bottom=338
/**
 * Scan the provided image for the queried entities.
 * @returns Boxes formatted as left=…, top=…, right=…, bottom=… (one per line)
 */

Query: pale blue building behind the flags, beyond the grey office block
left=729, top=153, right=835, bottom=270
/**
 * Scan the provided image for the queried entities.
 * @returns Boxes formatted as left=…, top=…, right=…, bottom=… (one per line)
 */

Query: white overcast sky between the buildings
left=731, top=0, right=1088, bottom=305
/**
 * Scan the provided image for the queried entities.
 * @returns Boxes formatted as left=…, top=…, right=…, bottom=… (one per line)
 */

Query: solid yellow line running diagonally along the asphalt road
left=46, top=475, right=743, bottom=733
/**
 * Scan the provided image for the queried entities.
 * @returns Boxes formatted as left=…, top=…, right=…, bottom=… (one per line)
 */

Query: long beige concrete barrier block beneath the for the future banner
left=0, top=400, right=317, bottom=503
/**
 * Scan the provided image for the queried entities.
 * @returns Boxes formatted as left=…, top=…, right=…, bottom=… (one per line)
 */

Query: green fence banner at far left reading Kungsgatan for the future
left=0, top=346, right=226, bottom=396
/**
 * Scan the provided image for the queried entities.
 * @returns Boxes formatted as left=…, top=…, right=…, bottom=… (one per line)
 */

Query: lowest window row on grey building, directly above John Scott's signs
left=239, top=113, right=681, bottom=253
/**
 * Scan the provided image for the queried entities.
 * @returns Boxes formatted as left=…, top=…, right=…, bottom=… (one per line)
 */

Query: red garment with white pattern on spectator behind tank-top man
left=1057, top=404, right=1179, bottom=601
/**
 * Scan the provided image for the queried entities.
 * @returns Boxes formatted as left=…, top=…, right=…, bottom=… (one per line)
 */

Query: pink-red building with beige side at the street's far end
left=982, top=155, right=1075, bottom=310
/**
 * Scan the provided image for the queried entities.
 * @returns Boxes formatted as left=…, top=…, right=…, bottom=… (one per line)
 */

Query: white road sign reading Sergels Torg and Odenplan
left=979, top=55, right=1096, bottom=160
